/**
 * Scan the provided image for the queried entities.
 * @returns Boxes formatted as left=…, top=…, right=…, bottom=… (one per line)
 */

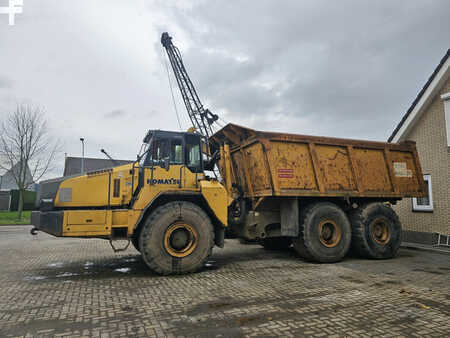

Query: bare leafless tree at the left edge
left=0, top=104, right=59, bottom=219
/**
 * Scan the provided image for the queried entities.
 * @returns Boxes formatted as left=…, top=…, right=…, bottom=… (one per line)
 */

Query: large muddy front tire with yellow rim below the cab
left=139, top=201, right=214, bottom=275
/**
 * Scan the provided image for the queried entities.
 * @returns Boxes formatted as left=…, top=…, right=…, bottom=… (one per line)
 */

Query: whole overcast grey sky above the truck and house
left=0, top=0, right=450, bottom=174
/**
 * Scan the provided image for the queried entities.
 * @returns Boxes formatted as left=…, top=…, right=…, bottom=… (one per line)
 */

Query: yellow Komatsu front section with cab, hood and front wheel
left=32, top=130, right=231, bottom=274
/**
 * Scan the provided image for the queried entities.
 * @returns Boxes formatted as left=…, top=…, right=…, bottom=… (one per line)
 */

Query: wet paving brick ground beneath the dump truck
left=0, top=227, right=450, bottom=337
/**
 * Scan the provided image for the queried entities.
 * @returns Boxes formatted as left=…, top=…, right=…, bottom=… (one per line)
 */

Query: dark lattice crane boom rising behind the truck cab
left=161, top=32, right=218, bottom=139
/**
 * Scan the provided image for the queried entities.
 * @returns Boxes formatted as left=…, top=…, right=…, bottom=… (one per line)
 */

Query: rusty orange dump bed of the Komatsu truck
left=210, top=124, right=425, bottom=199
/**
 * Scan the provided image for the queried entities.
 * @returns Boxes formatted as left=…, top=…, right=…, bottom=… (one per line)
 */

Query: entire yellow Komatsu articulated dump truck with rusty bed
left=32, top=124, right=425, bottom=274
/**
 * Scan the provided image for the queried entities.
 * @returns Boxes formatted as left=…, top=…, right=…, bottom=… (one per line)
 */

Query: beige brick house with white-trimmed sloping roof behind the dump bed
left=388, top=49, right=450, bottom=245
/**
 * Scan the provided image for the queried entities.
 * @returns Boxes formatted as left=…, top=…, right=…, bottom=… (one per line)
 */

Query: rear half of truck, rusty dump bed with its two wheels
left=210, top=124, right=425, bottom=262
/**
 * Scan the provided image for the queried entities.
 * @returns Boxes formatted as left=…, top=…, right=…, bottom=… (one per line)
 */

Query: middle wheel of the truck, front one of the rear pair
left=293, top=202, right=352, bottom=263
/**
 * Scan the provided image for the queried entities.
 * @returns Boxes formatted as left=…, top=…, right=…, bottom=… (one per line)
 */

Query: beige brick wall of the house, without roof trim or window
left=395, top=78, right=450, bottom=240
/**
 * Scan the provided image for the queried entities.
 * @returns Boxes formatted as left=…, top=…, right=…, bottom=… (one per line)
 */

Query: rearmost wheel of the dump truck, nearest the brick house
left=349, top=203, right=402, bottom=259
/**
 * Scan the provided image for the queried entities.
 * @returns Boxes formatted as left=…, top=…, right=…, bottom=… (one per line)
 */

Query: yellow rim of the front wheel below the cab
left=164, top=222, right=198, bottom=257
